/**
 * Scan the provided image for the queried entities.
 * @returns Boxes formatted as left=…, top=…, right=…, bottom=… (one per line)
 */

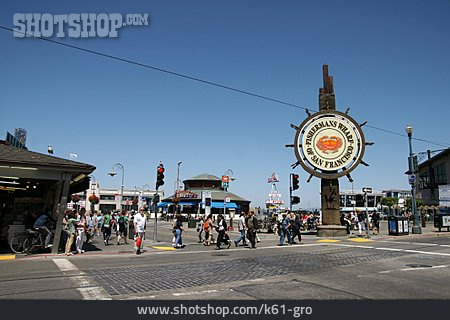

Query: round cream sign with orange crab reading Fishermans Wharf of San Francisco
left=294, top=110, right=365, bottom=179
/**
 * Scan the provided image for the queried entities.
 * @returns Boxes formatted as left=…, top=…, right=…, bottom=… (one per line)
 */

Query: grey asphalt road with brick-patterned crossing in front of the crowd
left=0, top=223, right=450, bottom=300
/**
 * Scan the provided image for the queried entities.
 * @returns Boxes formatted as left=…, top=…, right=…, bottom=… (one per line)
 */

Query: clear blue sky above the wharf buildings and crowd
left=0, top=0, right=450, bottom=208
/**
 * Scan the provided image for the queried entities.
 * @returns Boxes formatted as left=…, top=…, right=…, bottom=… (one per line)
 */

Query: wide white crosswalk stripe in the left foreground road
left=53, top=259, right=112, bottom=300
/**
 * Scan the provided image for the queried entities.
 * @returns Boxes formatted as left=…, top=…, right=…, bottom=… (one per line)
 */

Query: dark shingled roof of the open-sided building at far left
left=0, top=144, right=95, bottom=173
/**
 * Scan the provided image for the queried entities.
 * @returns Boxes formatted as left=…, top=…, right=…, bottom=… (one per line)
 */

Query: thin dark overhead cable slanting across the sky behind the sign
left=0, top=25, right=450, bottom=147
